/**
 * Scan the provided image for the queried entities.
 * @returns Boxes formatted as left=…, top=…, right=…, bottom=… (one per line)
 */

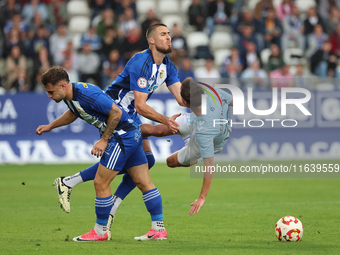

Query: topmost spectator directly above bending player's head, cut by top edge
left=47, top=0, right=67, bottom=28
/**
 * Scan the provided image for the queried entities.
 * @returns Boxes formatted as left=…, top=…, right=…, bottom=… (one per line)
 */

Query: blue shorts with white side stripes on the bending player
left=100, top=129, right=148, bottom=171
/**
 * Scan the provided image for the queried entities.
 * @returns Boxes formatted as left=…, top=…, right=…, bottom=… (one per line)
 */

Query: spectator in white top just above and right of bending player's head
left=78, top=43, right=100, bottom=87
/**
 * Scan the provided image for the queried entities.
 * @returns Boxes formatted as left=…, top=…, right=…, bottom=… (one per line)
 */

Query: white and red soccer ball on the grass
left=275, top=216, right=303, bottom=242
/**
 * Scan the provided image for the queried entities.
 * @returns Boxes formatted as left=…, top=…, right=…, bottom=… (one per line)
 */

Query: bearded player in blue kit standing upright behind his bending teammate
left=47, top=23, right=184, bottom=240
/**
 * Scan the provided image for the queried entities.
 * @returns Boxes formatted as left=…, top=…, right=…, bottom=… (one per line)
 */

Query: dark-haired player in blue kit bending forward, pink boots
left=36, top=67, right=167, bottom=241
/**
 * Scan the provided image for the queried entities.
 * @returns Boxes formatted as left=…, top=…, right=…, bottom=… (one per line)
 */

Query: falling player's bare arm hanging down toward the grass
left=189, top=156, right=214, bottom=216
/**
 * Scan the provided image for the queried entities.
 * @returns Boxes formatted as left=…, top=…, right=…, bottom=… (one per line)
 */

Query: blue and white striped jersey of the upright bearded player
left=105, top=49, right=179, bottom=116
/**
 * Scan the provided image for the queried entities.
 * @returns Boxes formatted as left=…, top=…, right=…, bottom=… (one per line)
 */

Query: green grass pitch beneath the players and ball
left=0, top=160, right=340, bottom=254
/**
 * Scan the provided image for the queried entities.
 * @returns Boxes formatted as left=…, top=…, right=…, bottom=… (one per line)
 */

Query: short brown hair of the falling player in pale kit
left=181, top=77, right=204, bottom=107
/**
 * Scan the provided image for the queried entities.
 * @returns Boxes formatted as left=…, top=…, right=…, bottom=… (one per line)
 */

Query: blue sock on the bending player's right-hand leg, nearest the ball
left=143, top=188, right=163, bottom=221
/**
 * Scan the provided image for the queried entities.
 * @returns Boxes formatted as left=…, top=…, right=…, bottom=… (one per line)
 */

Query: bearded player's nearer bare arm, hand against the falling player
left=133, top=90, right=178, bottom=133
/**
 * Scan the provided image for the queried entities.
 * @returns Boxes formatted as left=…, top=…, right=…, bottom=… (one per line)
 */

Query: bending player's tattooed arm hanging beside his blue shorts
left=91, top=103, right=122, bottom=157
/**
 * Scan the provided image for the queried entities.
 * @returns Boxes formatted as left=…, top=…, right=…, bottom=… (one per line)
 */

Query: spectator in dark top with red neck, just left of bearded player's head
left=122, top=28, right=144, bottom=60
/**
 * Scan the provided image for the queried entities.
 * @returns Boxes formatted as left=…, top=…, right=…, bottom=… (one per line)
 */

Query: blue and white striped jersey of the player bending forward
left=64, top=82, right=139, bottom=135
